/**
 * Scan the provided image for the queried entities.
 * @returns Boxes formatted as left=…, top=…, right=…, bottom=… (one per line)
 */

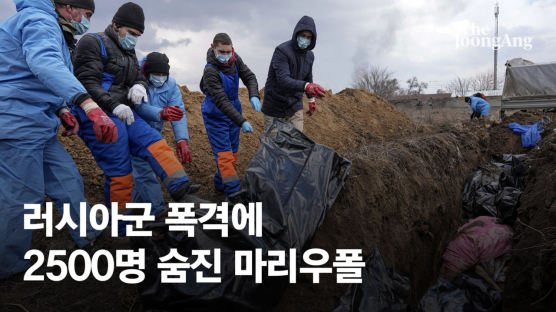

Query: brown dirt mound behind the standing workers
left=174, top=86, right=426, bottom=200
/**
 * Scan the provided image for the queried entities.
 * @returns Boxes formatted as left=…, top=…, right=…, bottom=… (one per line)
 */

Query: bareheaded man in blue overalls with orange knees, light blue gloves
left=200, top=33, right=261, bottom=202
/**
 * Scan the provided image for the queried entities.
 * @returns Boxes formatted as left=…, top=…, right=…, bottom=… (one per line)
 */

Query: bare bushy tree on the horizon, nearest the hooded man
left=353, top=65, right=400, bottom=98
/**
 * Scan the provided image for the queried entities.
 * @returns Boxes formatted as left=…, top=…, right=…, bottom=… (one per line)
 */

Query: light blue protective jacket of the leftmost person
left=0, top=0, right=89, bottom=142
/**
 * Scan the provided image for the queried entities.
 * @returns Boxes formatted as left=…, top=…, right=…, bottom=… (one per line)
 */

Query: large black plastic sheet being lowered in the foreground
left=132, top=121, right=351, bottom=311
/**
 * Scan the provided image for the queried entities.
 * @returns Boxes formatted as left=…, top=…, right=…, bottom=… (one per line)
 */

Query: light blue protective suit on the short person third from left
left=131, top=58, right=189, bottom=215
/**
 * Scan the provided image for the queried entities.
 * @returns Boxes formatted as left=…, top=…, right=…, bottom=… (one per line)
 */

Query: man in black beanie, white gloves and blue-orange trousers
left=73, top=2, right=200, bottom=214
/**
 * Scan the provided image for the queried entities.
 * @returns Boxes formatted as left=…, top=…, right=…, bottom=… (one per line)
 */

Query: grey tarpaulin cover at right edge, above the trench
left=502, top=63, right=556, bottom=100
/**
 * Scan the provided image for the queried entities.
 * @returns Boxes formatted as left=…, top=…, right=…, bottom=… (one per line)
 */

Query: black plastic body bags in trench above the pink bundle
left=463, top=154, right=527, bottom=225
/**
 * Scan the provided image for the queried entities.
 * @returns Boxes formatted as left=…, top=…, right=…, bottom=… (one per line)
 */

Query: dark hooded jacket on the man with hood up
left=262, top=16, right=317, bottom=118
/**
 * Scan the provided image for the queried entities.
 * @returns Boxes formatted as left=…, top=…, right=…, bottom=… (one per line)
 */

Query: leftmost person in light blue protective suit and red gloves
left=0, top=0, right=118, bottom=279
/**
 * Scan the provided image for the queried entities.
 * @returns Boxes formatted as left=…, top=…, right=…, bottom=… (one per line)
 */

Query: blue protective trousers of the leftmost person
left=0, top=136, right=100, bottom=279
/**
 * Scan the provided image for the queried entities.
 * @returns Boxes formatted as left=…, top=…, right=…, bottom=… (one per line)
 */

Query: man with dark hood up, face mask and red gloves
left=262, top=16, right=326, bottom=131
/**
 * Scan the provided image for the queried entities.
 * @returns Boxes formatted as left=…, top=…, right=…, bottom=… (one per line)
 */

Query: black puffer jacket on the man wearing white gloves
left=73, top=25, right=148, bottom=113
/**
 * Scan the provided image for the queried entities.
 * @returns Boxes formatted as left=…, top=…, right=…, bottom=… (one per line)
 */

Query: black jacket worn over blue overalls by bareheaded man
left=200, top=48, right=259, bottom=127
